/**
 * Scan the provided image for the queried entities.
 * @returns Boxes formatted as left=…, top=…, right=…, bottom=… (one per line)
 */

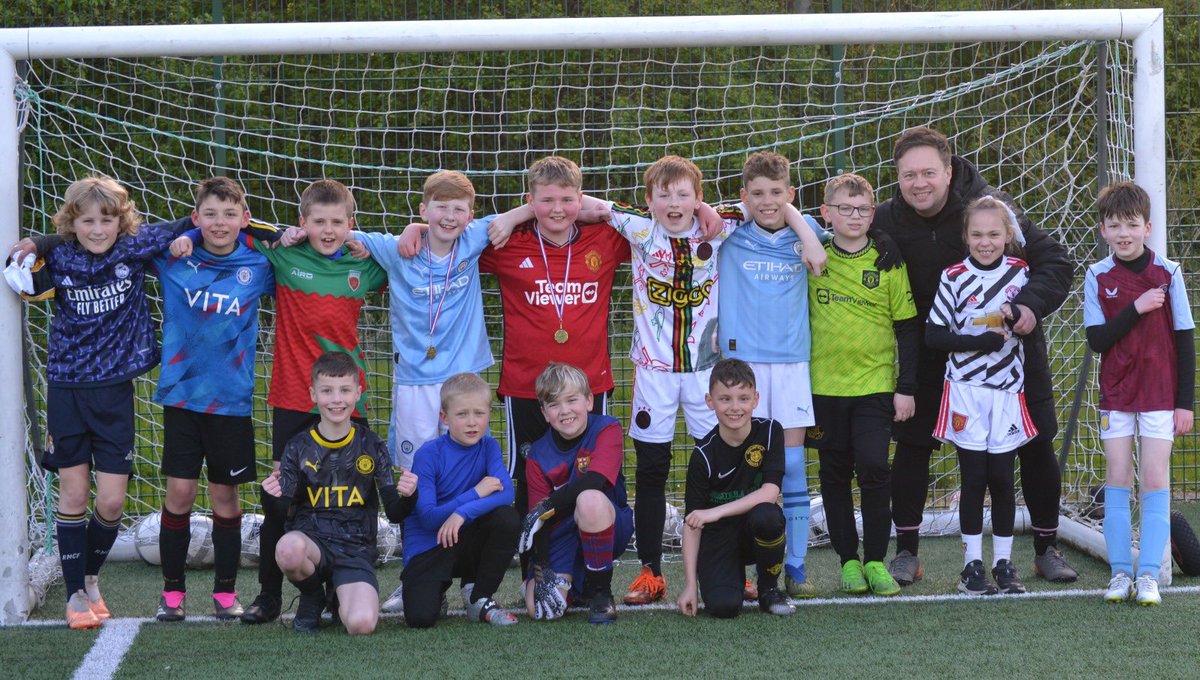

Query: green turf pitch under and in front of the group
left=14, top=505, right=1200, bottom=679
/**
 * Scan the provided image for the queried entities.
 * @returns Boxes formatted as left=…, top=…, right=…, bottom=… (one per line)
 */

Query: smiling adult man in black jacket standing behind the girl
left=872, top=127, right=1078, bottom=585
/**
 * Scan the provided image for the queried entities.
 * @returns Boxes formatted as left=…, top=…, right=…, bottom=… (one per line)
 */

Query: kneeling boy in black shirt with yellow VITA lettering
left=263, top=351, right=416, bottom=634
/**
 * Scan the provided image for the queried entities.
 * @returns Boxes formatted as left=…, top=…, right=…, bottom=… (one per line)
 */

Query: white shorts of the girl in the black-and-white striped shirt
left=934, top=380, right=1038, bottom=453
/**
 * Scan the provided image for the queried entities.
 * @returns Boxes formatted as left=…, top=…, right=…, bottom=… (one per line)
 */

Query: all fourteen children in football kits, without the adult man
left=6, top=125, right=1194, bottom=633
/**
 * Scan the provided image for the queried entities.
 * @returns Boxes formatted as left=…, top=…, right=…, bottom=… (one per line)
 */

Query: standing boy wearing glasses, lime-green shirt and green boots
left=806, top=173, right=919, bottom=596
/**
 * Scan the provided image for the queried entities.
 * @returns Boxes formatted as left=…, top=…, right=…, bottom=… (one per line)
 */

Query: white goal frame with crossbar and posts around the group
left=0, top=10, right=1168, bottom=625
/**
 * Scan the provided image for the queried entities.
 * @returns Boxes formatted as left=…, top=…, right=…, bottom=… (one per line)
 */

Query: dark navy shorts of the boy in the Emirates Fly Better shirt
left=41, top=380, right=133, bottom=475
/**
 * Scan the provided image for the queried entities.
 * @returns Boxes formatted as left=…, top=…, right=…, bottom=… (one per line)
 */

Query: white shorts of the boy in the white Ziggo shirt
left=629, top=366, right=716, bottom=444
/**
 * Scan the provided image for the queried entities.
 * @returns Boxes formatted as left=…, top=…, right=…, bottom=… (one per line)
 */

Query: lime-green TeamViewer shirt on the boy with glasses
left=809, top=241, right=917, bottom=397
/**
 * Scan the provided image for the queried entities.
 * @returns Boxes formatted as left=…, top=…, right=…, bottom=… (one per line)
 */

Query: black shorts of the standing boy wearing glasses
left=804, top=392, right=892, bottom=453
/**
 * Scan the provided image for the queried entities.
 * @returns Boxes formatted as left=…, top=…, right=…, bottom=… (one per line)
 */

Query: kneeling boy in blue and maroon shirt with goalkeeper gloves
left=521, top=363, right=634, bottom=624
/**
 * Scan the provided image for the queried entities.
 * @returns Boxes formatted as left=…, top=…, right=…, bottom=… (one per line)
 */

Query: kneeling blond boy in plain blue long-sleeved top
left=402, top=373, right=521, bottom=628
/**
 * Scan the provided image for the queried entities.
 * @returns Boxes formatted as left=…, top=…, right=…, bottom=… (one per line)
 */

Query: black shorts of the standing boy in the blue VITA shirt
left=161, top=407, right=258, bottom=485
